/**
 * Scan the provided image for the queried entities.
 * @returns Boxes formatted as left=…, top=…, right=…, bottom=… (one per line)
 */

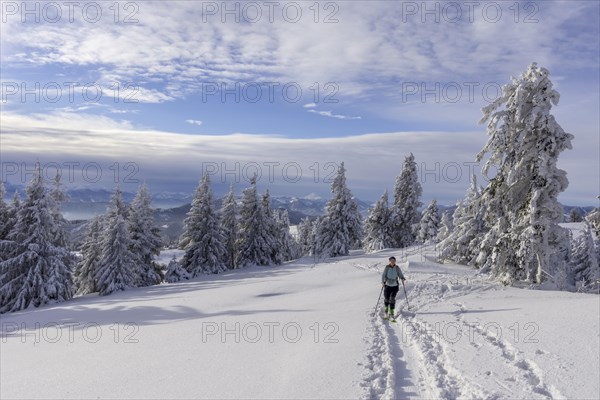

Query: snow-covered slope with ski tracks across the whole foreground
left=0, top=248, right=600, bottom=399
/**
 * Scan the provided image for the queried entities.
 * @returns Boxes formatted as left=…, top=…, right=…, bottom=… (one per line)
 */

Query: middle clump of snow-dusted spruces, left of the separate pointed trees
left=165, top=175, right=298, bottom=282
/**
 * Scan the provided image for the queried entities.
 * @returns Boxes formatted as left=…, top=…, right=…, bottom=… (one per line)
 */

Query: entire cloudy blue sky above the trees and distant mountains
left=0, top=1, right=600, bottom=205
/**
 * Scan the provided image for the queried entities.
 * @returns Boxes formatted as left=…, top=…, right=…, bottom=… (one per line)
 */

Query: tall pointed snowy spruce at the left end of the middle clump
left=181, top=174, right=227, bottom=277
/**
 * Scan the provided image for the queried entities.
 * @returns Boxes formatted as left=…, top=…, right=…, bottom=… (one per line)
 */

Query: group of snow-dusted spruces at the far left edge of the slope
left=0, top=165, right=163, bottom=312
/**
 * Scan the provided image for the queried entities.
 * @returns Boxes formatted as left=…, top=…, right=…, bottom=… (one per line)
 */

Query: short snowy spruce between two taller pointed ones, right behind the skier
left=364, top=190, right=395, bottom=253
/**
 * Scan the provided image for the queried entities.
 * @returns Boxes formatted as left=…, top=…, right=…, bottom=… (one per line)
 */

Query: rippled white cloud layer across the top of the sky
left=1, top=1, right=598, bottom=108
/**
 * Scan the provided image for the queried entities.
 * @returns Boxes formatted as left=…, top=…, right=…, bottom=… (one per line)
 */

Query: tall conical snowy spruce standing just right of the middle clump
left=317, top=162, right=362, bottom=257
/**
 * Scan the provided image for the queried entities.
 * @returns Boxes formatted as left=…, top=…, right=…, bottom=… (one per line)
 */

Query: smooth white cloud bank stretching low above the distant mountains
left=0, top=112, right=600, bottom=204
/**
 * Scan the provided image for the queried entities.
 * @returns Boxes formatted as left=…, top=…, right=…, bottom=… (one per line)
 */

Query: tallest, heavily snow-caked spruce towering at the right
left=477, top=63, right=573, bottom=283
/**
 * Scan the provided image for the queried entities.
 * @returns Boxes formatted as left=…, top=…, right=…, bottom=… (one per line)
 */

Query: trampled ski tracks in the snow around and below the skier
left=351, top=263, right=565, bottom=400
